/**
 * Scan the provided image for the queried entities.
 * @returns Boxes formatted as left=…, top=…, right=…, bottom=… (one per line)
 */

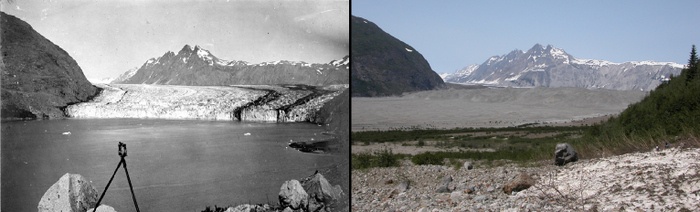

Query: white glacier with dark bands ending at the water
left=66, top=84, right=346, bottom=122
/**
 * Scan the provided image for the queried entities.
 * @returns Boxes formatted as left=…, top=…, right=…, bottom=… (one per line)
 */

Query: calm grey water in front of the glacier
left=2, top=119, right=340, bottom=211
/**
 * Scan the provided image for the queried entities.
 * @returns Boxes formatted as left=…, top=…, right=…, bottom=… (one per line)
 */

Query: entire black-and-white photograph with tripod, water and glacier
left=0, top=0, right=350, bottom=212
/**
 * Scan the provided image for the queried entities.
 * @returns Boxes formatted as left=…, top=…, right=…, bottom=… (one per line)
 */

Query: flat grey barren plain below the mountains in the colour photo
left=351, top=88, right=646, bottom=131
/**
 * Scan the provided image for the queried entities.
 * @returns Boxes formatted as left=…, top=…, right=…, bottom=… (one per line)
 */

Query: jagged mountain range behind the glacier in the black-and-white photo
left=112, top=45, right=349, bottom=86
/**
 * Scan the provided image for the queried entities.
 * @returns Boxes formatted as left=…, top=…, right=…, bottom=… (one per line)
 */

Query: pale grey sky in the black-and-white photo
left=2, top=0, right=350, bottom=79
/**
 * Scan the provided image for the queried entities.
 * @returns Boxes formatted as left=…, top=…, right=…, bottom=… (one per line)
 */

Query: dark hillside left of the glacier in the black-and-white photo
left=0, top=13, right=97, bottom=119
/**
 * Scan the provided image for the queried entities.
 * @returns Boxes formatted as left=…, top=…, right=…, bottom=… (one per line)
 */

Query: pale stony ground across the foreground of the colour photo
left=351, top=148, right=700, bottom=211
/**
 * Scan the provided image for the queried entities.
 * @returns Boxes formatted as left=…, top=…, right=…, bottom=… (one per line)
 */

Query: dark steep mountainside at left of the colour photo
left=351, top=16, right=445, bottom=96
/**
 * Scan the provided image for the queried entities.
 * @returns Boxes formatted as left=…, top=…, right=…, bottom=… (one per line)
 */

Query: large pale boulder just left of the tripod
left=38, top=173, right=101, bottom=212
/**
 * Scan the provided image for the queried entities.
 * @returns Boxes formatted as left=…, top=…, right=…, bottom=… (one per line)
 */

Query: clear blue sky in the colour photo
left=351, top=0, right=700, bottom=73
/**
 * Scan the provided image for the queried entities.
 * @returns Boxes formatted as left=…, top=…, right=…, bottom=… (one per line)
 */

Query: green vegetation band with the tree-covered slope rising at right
left=351, top=46, right=700, bottom=169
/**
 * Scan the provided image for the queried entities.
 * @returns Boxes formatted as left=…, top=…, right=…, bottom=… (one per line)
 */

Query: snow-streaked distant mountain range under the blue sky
left=444, top=44, right=683, bottom=91
